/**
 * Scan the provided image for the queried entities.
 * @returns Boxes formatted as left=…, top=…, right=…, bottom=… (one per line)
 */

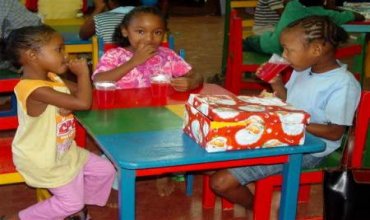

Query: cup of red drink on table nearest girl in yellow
left=94, top=81, right=116, bottom=109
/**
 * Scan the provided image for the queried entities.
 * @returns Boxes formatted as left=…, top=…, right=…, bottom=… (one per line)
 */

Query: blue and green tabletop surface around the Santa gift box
left=76, top=107, right=325, bottom=169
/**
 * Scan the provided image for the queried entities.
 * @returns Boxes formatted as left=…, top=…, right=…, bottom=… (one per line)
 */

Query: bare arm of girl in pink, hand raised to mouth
left=94, top=43, right=157, bottom=82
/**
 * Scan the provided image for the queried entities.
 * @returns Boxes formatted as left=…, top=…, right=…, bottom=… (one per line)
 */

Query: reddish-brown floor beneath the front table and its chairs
left=0, top=139, right=322, bottom=220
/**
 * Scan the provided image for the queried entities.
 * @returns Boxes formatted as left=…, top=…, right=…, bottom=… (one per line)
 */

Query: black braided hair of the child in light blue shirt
left=286, top=16, right=348, bottom=48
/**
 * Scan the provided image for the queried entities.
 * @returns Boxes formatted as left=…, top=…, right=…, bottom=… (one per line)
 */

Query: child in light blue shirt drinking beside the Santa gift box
left=211, top=16, right=361, bottom=219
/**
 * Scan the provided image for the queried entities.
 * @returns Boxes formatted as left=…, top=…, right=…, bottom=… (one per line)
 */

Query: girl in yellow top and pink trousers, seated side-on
left=3, top=26, right=115, bottom=220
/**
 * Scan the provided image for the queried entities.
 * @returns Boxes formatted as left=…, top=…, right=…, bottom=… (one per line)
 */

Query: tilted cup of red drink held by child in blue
left=258, top=54, right=289, bottom=82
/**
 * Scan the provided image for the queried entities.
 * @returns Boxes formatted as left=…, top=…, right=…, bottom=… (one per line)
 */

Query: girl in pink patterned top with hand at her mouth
left=92, top=6, right=203, bottom=91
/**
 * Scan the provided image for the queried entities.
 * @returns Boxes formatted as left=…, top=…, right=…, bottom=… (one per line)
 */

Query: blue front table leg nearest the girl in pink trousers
left=118, top=169, right=136, bottom=220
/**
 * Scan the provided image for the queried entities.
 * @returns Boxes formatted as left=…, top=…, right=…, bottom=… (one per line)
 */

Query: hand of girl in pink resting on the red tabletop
left=171, top=71, right=203, bottom=92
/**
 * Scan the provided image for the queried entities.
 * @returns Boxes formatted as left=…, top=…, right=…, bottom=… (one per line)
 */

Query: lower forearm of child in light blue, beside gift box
left=306, top=123, right=346, bottom=141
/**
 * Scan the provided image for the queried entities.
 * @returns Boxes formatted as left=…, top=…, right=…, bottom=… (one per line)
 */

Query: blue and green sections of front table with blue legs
left=76, top=103, right=325, bottom=220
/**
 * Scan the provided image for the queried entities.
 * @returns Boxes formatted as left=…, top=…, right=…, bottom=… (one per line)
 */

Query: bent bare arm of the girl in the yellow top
left=27, top=59, right=92, bottom=116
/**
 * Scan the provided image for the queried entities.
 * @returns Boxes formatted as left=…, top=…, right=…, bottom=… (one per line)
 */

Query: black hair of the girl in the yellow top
left=1, top=25, right=56, bottom=68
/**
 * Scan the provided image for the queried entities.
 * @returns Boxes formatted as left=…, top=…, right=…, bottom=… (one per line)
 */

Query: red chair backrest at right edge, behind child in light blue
left=351, top=91, right=370, bottom=168
